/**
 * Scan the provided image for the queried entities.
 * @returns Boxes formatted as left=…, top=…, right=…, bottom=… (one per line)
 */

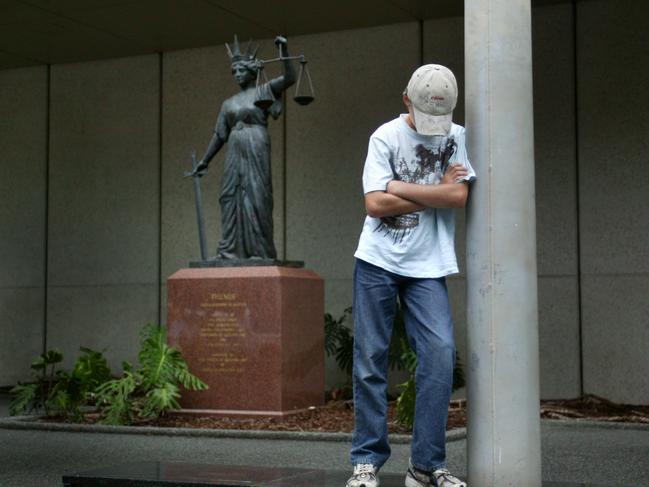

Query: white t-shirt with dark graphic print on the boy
left=354, top=115, right=475, bottom=278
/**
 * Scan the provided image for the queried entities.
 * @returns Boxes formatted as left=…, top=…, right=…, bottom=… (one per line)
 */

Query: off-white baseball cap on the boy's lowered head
left=406, top=64, right=457, bottom=135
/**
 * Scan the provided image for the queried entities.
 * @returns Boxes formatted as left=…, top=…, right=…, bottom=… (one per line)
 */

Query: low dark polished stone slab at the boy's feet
left=63, top=462, right=616, bottom=487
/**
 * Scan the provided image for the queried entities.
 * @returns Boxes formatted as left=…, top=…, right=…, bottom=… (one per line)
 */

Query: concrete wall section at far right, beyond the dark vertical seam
left=577, top=0, right=649, bottom=403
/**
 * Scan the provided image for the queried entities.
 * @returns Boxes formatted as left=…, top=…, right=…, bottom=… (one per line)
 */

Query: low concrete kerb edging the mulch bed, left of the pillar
left=0, top=416, right=466, bottom=444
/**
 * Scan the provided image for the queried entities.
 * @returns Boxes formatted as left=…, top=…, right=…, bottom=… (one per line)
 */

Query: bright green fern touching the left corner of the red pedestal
left=97, top=324, right=208, bottom=424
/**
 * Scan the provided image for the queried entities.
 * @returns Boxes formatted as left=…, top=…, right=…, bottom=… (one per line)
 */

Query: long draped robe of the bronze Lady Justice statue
left=215, top=86, right=277, bottom=259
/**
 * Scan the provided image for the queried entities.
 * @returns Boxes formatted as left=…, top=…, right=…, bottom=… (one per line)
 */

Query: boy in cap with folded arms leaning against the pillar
left=347, top=64, right=475, bottom=487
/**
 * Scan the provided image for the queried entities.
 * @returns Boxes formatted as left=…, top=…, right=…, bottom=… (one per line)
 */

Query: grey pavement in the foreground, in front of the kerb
left=0, top=392, right=649, bottom=487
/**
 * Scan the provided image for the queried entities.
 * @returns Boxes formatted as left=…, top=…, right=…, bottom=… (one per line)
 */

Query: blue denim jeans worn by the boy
left=350, top=259, right=455, bottom=471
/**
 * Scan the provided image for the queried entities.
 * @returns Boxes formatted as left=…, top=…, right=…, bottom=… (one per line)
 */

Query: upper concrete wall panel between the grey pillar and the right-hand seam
left=533, top=4, right=578, bottom=278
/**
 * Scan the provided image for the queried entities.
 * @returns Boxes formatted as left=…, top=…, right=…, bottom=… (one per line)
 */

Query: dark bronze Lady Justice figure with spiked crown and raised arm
left=191, top=36, right=295, bottom=260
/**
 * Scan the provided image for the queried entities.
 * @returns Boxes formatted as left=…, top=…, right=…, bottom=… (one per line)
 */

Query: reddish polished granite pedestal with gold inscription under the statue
left=167, top=266, right=324, bottom=416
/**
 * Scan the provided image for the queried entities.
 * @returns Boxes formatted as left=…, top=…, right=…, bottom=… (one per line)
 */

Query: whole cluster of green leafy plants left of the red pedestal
left=9, top=324, right=207, bottom=424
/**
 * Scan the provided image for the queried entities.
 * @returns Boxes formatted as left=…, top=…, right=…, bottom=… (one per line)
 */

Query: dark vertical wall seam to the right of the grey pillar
left=572, top=0, right=584, bottom=396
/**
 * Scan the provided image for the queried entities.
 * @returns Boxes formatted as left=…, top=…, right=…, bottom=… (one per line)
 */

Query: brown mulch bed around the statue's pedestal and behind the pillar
left=38, top=395, right=649, bottom=434
